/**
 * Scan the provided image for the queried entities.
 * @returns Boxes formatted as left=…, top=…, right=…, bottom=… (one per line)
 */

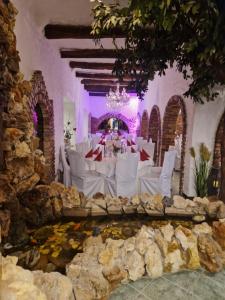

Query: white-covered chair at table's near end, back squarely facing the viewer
left=105, top=153, right=139, bottom=197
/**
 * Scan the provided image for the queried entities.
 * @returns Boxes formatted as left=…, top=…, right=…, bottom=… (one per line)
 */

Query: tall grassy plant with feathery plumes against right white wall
left=190, top=143, right=211, bottom=197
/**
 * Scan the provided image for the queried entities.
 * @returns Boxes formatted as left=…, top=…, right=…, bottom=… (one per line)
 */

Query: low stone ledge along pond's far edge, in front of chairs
left=63, top=193, right=225, bottom=221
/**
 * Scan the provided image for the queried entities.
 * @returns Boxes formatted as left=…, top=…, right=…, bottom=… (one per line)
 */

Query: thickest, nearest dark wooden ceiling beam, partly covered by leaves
left=44, top=24, right=125, bottom=39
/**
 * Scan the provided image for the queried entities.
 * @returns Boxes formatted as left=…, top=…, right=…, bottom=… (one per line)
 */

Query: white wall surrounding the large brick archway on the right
left=140, top=69, right=225, bottom=196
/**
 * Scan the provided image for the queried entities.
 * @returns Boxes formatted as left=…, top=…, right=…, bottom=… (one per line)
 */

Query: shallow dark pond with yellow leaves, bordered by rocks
left=3, top=216, right=193, bottom=273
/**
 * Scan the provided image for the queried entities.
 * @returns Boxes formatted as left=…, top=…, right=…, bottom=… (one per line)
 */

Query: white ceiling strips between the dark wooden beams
left=15, top=0, right=128, bottom=90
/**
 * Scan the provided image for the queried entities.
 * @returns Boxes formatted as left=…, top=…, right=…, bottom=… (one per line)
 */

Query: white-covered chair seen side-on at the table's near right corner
left=139, top=151, right=176, bottom=197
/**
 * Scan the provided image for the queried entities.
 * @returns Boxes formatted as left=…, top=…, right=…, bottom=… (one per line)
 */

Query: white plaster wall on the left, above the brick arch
left=13, top=0, right=89, bottom=169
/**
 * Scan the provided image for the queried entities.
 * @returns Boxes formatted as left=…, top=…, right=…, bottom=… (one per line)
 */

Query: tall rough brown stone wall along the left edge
left=0, top=1, right=44, bottom=240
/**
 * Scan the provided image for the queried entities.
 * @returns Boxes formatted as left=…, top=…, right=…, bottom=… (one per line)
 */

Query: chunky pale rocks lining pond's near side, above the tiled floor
left=67, top=222, right=225, bottom=300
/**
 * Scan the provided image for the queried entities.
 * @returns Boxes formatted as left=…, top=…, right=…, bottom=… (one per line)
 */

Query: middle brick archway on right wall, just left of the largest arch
left=148, top=105, right=162, bottom=165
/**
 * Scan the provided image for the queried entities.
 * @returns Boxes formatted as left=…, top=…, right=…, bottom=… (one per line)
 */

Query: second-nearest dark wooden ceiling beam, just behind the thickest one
left=60, top=49, right=119, bottom=58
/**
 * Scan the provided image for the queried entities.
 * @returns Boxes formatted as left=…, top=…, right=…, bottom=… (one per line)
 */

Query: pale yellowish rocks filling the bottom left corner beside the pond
left=0, top=256, right=73, bottom=300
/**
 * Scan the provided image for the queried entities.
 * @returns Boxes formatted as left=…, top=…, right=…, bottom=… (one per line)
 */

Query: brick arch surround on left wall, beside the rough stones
left=29, top=71, right=55, bottom=182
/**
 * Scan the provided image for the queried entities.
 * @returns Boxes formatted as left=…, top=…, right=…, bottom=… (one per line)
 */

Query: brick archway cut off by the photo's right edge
left=213, top=112, right=225, bottom=201
